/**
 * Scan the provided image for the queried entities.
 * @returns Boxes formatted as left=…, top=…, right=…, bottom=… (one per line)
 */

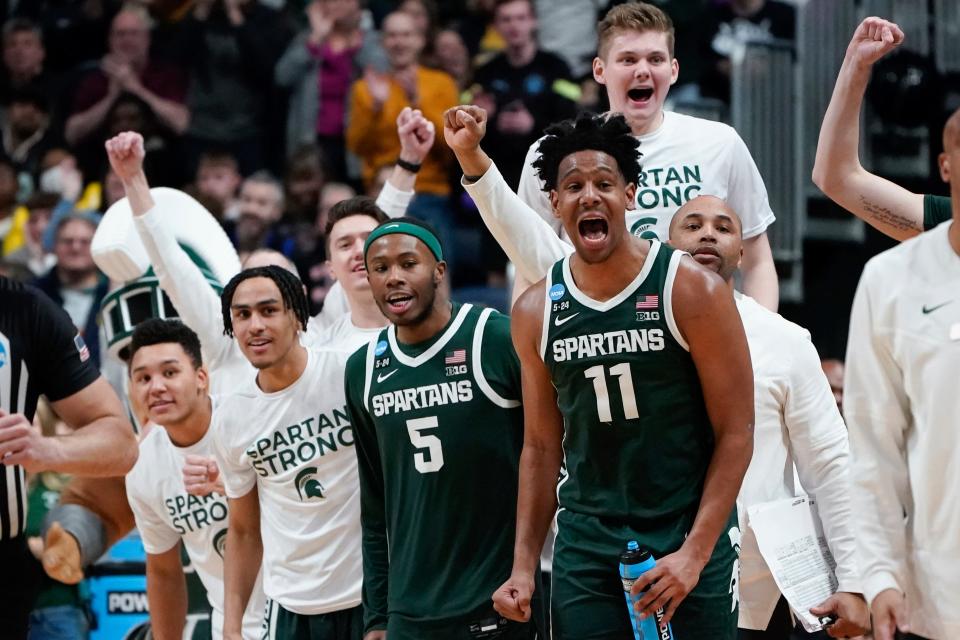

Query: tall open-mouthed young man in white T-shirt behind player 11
left=515, top=2, right=779, bottom=309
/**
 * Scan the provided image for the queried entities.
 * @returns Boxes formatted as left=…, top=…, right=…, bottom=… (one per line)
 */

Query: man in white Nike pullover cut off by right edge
left=844, top=106, right=960, bottom=640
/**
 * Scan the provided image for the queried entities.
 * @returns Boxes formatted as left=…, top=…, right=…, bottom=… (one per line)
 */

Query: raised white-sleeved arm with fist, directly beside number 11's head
left=443, top=105, right=573, bottom=282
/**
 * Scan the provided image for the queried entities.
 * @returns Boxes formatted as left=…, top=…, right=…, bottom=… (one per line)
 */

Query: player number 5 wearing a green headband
left=346, top=218, right=537, bottom=640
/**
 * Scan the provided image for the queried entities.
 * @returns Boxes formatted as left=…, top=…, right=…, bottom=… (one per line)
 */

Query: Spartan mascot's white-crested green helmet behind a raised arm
left=91, top=187, right=240, bottom=359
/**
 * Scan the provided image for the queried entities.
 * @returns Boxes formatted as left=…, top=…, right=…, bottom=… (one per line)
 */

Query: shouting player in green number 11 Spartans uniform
left=488, top=112, right=753, bottom=640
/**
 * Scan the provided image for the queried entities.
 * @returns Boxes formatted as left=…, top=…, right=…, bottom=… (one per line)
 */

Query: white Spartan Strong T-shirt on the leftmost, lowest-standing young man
left=126, top=398, right=265, bottom=640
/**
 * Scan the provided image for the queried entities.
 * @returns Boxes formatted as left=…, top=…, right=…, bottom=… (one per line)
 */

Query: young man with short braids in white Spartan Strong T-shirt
left=213, top=266, right=362, bottom=640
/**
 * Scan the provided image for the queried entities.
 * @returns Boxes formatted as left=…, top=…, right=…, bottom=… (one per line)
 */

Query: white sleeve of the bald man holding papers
left=783, top=336, right=862, bottom=593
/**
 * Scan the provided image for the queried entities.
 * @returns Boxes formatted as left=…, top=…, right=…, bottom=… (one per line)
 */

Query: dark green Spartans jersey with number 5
left=346, top=304, right=523, bottom=630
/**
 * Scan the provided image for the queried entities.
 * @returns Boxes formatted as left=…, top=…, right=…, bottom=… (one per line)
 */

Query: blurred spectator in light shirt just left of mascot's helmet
left=35, top=214, right=109, bottom=368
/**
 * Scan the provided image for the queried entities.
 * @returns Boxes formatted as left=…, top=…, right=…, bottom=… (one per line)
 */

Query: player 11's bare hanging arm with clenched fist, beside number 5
left=493, top=280, right=563, bottom=621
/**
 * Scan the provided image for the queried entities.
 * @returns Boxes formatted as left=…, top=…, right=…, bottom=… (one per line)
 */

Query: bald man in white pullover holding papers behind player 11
left=670, top=196, right=870, bottom=640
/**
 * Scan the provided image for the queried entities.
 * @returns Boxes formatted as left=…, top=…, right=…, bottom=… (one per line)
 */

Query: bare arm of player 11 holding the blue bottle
left=633, top=256, right=753, bottom=621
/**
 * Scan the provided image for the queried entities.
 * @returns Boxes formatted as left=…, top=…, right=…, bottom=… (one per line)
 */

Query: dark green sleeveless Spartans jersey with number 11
left=540, top=240, right=713, bottom=532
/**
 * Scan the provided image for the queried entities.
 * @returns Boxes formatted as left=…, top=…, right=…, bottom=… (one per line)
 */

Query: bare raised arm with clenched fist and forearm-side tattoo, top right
left=813, top=18, right=923, bottom=240
